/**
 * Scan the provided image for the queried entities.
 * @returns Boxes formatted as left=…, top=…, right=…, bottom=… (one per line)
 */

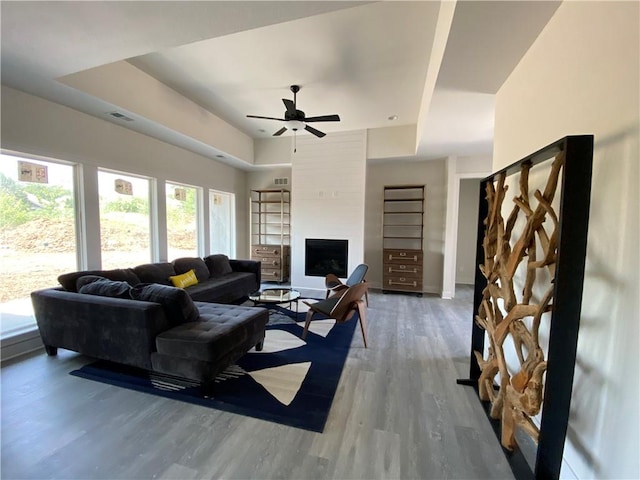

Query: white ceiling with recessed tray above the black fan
left=0, top=1, right=559, bottom=168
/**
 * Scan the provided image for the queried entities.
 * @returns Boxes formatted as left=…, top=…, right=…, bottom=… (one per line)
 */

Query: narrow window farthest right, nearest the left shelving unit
left=209, top=190, right=236, bottom=258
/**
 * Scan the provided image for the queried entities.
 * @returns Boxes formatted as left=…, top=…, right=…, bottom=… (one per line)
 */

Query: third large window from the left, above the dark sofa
left=166, top=183, right=199, bottom=260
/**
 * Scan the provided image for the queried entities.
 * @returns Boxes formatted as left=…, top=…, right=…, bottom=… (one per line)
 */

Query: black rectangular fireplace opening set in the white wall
left=304, top=238, right=349, bottom=278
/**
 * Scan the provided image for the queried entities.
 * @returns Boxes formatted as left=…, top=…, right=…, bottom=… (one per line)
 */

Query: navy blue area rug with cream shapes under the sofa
left=71, top=302, right=358, bottom=432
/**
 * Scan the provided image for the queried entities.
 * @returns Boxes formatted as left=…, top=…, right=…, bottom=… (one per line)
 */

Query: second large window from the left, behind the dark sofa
left=98, top=170, right=151, bottom=269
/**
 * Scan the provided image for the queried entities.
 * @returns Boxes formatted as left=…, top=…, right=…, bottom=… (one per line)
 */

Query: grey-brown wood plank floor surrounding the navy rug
left=1, top=286, right=513, bottom=479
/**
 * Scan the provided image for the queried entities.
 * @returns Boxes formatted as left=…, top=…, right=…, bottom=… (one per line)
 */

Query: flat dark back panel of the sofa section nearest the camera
left=31, top=288, right=171, bottom=368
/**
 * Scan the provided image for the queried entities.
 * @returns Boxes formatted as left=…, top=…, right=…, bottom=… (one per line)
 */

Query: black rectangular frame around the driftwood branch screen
left=458, top=135, right=593, bottom=479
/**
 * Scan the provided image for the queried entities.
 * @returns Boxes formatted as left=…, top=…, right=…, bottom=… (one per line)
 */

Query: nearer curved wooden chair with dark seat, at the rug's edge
left=302, top=282, right=369, bottom=348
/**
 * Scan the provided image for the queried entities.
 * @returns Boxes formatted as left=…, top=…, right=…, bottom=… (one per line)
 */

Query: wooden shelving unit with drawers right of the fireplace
left=382, top=185, right=424, bottom=296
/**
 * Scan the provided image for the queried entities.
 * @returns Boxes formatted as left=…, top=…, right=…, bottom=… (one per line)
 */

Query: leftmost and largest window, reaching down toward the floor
left=0, top=155, right=77, bottom=338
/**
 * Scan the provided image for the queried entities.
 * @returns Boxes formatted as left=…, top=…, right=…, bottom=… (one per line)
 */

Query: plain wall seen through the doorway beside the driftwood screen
left=456, top=178, right=480, bottom=285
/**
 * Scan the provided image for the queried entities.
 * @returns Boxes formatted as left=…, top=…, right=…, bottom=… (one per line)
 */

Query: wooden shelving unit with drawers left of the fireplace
left=249, top=189, right=291, bottom=283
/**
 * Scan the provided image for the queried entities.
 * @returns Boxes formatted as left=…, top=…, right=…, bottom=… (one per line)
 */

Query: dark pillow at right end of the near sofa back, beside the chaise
left=130, top=283, right=200, bottom=325
